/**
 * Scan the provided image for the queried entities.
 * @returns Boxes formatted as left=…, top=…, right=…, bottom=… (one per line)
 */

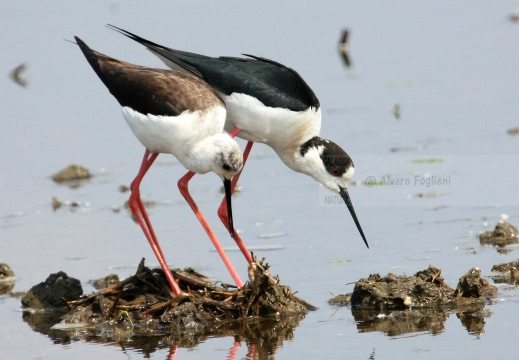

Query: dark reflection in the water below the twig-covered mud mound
left=22, top=312, right=304, bottom=359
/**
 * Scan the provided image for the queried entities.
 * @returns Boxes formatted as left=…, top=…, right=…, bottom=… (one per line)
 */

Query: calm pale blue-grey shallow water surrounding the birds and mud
left=0, top=1, right=519, bottom=359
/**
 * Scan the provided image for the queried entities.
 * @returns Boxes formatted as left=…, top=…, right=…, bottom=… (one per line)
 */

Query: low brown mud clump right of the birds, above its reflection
left=336, top=266, right=497, bottom=309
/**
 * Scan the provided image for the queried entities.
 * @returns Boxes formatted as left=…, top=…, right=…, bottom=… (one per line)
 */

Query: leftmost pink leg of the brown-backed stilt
left=128, top=149, right=181, bottom=296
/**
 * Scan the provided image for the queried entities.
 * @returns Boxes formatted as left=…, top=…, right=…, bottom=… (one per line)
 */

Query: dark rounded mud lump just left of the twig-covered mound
left=22, top=271, right=83, bottom=311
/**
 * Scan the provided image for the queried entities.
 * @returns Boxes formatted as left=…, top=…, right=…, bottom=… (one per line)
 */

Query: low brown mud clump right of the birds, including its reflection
left=329, top=266, right=497, bottom=336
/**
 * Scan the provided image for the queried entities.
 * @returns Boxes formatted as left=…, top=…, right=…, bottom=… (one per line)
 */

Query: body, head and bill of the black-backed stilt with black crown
left=108, top=25, right=369, bottom=247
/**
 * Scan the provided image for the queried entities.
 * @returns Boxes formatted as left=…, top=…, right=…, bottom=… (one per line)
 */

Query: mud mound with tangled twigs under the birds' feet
left=53, top=261, right=313, bottom=336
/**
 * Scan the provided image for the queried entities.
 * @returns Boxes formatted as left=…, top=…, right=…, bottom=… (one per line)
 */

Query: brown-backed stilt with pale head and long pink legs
left=75, top=37, right=247, bottom=296
